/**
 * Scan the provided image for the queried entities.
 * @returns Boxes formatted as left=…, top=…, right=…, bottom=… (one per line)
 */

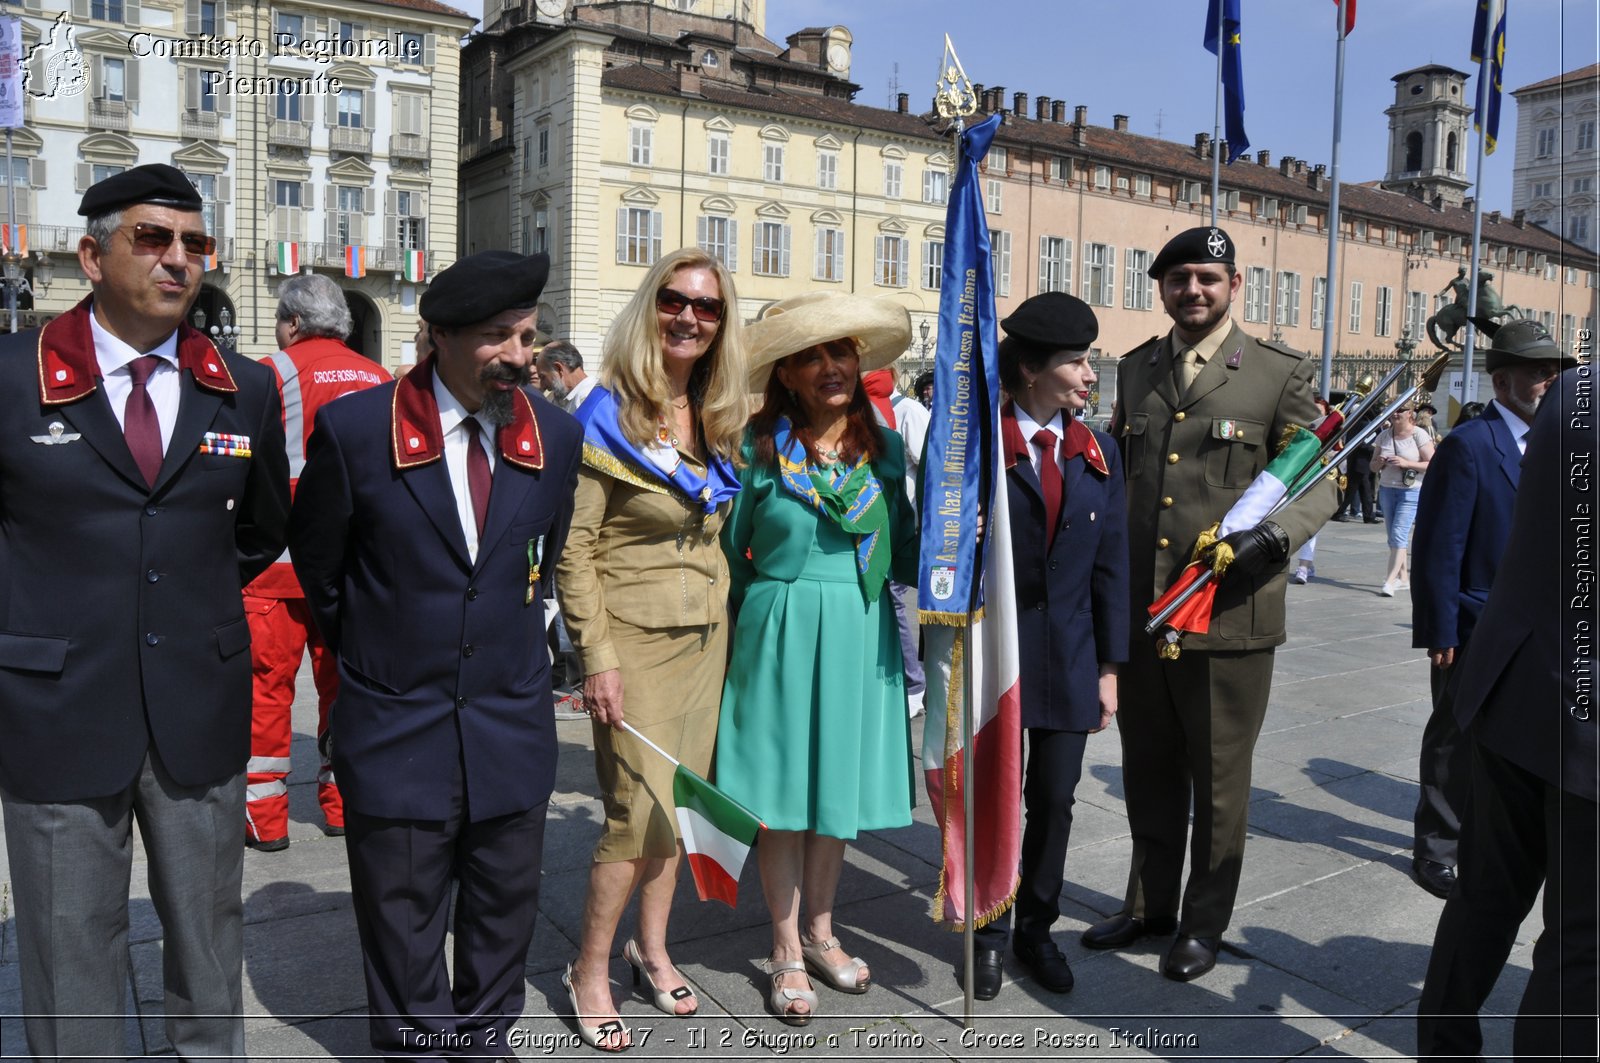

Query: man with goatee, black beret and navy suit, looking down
left=290, top=251, right=582, bottom=1057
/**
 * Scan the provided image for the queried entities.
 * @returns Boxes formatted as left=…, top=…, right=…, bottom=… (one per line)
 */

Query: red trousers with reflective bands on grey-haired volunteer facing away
left=245, top=594, right=344, bottom=842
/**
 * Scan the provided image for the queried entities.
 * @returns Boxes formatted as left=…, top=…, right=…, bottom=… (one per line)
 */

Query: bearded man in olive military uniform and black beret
left=1083, top=226, right=1338, bottom=981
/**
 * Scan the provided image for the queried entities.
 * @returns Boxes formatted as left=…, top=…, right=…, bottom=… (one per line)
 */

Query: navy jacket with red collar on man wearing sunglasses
left=0, top=299, right=290, bottom=802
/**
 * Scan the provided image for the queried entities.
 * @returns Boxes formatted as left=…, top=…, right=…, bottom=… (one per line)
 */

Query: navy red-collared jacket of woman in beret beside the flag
left=1000, top=403, right=1128, bottom=732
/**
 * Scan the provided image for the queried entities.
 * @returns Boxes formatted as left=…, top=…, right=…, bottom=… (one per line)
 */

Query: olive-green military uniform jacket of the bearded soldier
left=1110, top=325, right=1339, bottom=653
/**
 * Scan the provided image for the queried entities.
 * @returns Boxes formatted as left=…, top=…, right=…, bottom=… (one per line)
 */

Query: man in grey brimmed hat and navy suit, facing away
left=1411, top=319, right=1576, bottom=915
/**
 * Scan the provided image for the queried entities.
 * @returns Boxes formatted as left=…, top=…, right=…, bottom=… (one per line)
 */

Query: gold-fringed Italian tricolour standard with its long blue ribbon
left=917, top=108, right=1022, bottom=929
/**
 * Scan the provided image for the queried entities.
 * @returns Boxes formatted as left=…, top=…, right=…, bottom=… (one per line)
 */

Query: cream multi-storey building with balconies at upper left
left=9, top=0, right=472, bottom=367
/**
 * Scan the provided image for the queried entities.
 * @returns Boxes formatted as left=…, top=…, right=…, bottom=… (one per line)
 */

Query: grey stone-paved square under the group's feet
left=0, top=523, right=1538, bottom=1060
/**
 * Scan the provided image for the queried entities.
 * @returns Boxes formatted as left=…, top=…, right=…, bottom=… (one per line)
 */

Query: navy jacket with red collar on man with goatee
left=290, top=359, right=582, bottom=821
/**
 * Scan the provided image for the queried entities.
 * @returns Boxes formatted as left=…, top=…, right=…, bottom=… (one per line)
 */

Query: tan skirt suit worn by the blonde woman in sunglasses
left=557, top=450, right=731, bottom=863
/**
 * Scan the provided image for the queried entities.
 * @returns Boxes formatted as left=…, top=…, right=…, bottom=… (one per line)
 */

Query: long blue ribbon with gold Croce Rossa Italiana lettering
left=917, top=114, right=1000, bottom=626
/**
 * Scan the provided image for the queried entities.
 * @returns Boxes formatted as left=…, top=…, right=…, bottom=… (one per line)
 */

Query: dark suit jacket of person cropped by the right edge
left=1465, top=367, right=1600, bottom=800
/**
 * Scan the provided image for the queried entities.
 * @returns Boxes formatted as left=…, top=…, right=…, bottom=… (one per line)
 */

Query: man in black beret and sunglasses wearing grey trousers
left=0, top=165, right=290, bottom=1058
